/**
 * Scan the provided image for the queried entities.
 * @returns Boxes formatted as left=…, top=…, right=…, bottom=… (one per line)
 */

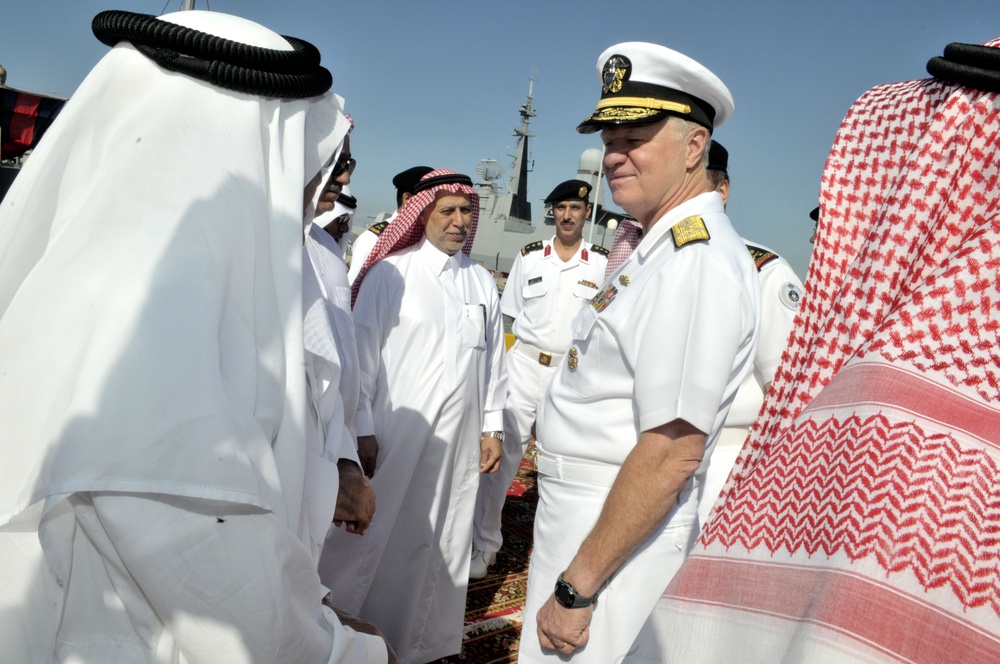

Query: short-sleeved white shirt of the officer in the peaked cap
left=538, top=192, right=759, bottom=488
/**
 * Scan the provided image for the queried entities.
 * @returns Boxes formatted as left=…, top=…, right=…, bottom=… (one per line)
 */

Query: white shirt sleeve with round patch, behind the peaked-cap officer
left=726, top=242, right=802, bottom=428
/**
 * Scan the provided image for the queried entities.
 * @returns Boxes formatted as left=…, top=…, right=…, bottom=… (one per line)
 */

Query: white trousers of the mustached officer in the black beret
left=472, top=340, right=562, bottom=553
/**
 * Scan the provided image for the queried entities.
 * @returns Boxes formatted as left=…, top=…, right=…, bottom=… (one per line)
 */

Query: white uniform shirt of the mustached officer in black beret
left=500, top=238, right=608, bottom=353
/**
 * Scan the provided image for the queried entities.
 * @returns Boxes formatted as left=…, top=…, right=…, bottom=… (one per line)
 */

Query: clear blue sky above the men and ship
left=0, top=0, right=1000, bottom=277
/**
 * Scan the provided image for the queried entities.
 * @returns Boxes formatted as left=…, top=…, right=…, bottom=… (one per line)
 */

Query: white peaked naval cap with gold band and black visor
left=576, top=42, right=733, bottom=134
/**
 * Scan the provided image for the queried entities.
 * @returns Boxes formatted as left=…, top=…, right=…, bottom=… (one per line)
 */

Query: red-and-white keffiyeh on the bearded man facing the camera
left=351, top=168, right=479, bottom=308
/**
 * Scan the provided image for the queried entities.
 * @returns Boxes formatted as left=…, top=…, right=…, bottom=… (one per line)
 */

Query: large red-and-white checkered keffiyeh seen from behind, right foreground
left=658, top=39, right=1000, bottom=662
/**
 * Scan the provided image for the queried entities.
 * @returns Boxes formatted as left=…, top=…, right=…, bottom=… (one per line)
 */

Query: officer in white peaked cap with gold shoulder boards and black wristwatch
left=519, top=42, right=759, bottom=664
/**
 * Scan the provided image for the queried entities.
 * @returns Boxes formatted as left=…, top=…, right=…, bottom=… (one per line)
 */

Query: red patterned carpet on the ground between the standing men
left=440, top=447, right=538, bottom=664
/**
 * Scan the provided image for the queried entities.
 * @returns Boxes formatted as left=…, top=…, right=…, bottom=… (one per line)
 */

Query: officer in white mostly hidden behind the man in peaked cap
left=698, top=141, right=802, bottom=528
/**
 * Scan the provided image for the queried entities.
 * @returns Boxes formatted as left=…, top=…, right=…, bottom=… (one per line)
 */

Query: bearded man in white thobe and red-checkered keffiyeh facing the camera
left=323, top=170, right=506, bottom=663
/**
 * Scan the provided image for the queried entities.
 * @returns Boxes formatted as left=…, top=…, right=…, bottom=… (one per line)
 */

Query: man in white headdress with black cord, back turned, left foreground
left=0, top=11, right=387, bottom=664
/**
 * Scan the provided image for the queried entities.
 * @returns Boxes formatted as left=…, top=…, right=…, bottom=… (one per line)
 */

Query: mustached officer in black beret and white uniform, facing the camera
left=469, top=180, right=608, bottom=579
